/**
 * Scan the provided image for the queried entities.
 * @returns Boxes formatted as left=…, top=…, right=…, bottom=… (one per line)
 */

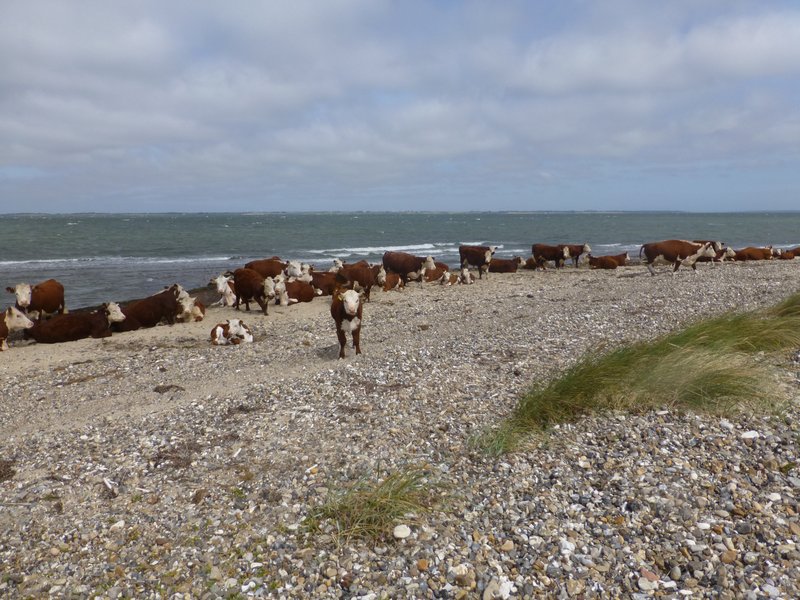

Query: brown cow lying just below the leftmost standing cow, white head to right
left=23, top=302, right=126, bottom=344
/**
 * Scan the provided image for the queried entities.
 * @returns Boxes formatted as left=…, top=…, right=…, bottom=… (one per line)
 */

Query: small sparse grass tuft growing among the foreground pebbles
left=304, top=467, right=436, bottom=543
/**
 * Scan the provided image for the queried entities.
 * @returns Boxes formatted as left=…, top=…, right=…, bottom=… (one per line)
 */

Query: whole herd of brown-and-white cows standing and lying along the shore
left=0, top=240, right=800, bottom=358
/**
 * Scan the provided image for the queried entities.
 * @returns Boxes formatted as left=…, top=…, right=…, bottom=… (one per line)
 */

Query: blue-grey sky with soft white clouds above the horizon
left=0, top=0, right=800, bottom=213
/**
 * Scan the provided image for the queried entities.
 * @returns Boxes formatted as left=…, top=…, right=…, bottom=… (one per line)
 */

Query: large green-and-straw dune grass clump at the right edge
left=488, top=294, right=800, bottom=454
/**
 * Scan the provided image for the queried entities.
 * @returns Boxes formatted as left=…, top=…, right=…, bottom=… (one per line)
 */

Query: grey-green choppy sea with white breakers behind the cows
left=0, top=212, right=800, bottom=308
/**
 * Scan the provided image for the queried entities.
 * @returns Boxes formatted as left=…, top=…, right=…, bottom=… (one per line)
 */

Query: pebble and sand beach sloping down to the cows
left=0, top=260, right=800, bottom=598
